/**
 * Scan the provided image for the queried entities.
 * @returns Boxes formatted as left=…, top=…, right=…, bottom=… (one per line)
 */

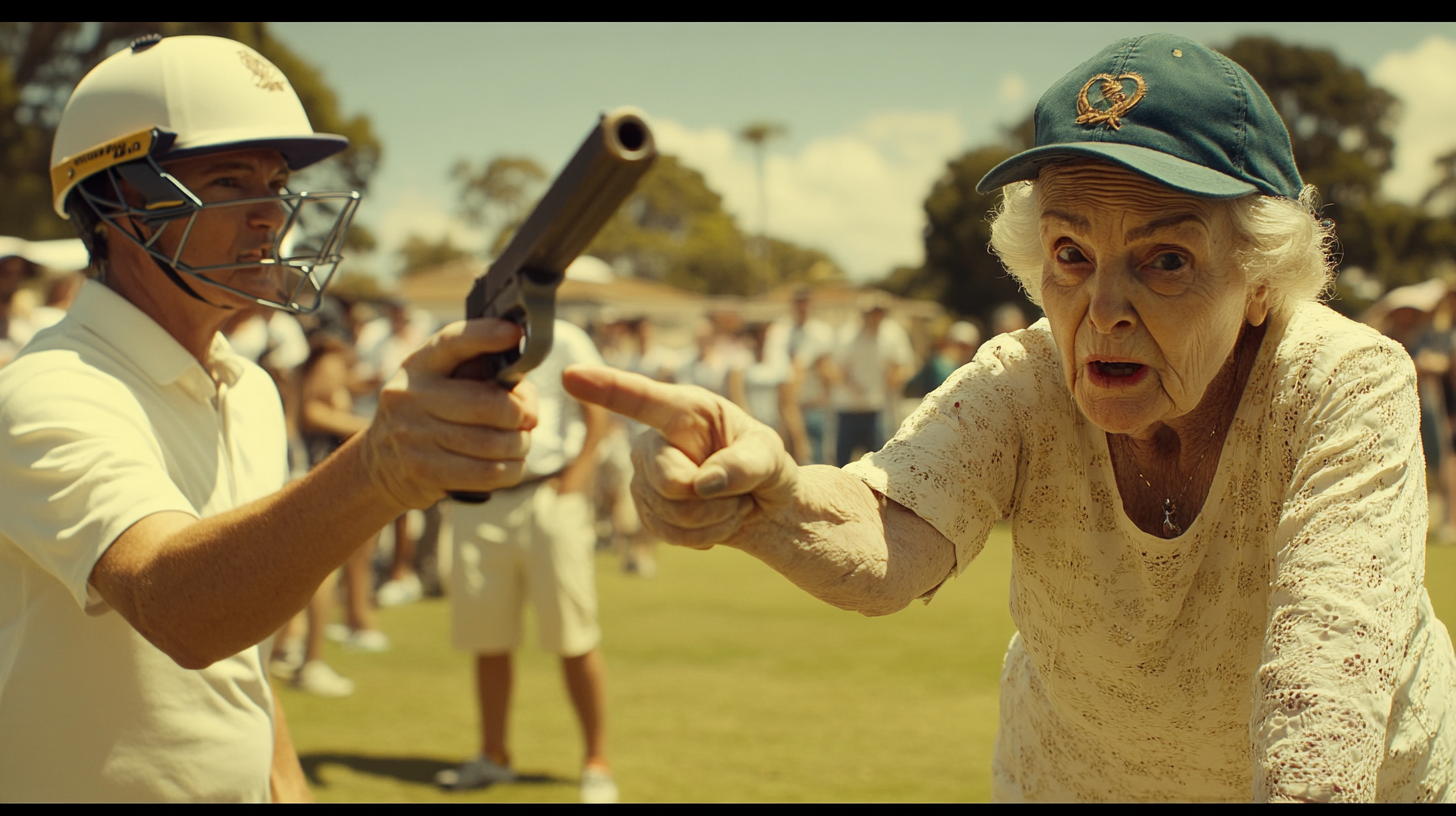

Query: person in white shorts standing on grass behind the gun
left=437, top=321, right=617, bottom=801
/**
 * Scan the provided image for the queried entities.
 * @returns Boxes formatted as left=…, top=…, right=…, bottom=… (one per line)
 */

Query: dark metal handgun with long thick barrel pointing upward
left=450, top=108, right=657, bottom=504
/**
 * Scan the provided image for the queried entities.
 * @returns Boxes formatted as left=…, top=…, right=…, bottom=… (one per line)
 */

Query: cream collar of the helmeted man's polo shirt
left=70, top=281, right=243, bottom=391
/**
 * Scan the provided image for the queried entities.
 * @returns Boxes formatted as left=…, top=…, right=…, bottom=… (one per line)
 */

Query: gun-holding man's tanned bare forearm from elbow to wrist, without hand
left=92, top=443, right=406, bottom=669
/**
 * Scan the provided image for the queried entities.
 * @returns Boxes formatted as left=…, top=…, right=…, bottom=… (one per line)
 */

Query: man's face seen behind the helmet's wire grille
left=159, top=150, right=288, bottom=300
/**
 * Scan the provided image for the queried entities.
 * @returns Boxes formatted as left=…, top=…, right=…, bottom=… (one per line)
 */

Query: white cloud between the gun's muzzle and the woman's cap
left=652, top=112, right=965, bottom=280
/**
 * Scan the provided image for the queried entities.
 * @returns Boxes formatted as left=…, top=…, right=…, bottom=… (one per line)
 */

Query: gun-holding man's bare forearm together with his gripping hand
left=90, top=311, right=537, bottom=669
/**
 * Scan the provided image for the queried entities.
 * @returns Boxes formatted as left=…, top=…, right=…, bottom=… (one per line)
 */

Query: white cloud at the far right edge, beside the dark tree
left=1370, top=35, right=1456, bottom=203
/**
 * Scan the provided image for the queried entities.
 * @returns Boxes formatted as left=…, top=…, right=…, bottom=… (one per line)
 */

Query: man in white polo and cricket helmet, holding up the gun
left=0, top=36, right=537, bottom=801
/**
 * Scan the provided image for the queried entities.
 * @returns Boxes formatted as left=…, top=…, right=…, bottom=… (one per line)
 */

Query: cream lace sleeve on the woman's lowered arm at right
left=1249, top=341, right=1427, bottom=801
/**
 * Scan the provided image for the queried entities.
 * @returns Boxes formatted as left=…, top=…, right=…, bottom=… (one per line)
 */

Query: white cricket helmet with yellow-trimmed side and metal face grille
left=51, top=35, right=360, bottom=312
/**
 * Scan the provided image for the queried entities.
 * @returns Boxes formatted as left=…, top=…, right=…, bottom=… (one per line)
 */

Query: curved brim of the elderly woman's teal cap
left=976, top=141, right=1259, bottom=198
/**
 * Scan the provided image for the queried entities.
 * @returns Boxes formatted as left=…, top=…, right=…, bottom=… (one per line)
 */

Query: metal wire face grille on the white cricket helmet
left=76, top=157, right=360, bottom=313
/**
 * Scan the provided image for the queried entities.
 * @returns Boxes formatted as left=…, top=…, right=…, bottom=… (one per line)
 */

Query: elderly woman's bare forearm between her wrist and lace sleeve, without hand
left=728, top=465, right=955, bottom=616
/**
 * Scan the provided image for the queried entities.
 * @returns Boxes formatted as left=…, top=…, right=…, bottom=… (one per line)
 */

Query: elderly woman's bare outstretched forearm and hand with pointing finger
left=563, top=366, right=955, bottom=615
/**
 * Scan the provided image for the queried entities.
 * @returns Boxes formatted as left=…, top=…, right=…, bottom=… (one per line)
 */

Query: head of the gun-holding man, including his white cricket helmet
left=51, top=35, right=358, bottom=312
